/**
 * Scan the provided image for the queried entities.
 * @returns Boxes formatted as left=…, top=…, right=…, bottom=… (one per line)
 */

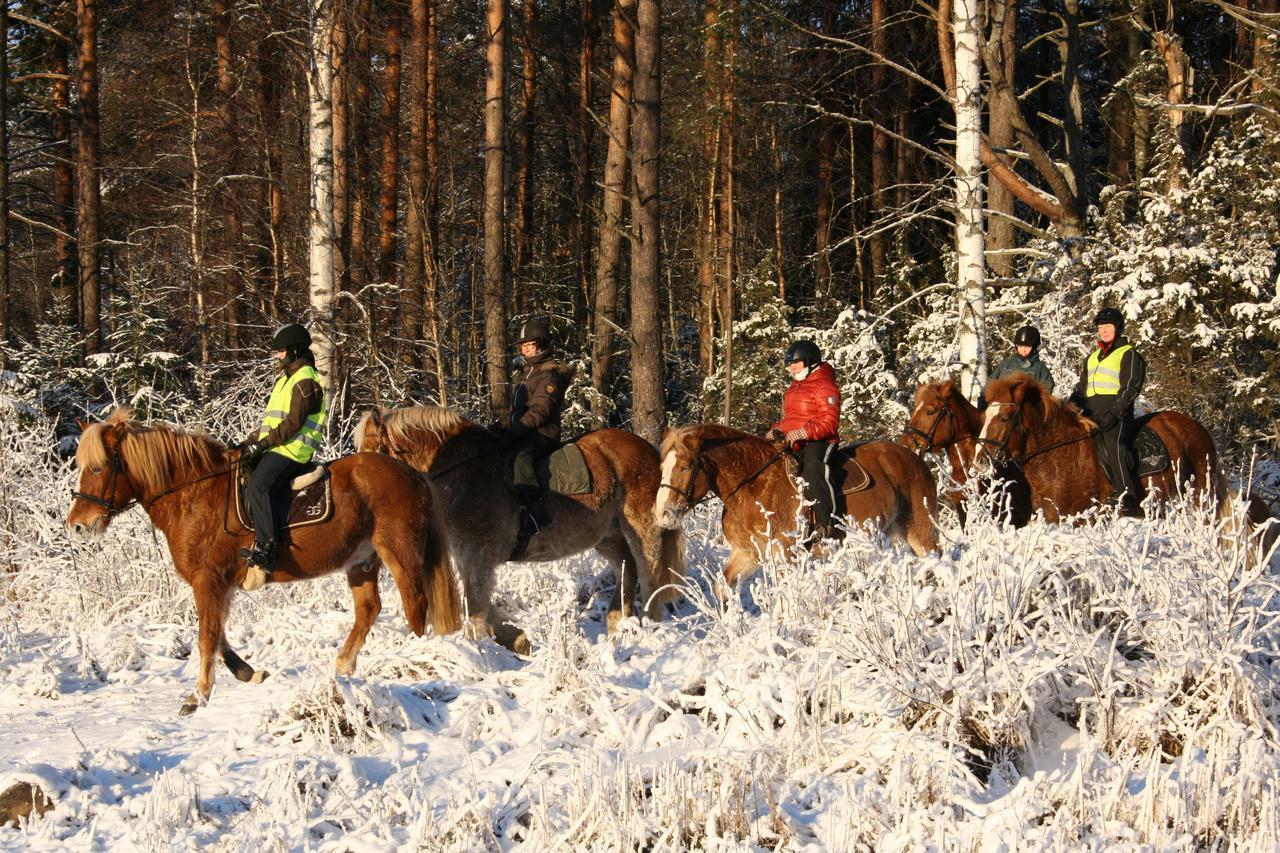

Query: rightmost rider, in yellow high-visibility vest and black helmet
left=1071, top=306, right=1147, bottom=515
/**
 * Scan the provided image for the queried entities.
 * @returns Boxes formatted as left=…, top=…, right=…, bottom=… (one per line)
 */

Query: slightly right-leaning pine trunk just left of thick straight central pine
left=584, top=0, right=635, bottom=418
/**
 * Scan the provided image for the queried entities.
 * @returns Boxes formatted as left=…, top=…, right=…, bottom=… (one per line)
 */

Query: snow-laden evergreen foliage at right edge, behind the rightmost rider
left=1037, top=118, right=1280, bottom=443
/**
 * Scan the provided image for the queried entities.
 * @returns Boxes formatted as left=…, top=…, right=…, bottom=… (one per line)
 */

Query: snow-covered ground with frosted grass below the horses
left=0, top=425, right=1280, bottom=850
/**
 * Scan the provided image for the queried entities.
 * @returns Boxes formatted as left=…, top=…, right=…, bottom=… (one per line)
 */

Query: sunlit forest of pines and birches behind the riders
left=0, top=0, right=1280, bottom=459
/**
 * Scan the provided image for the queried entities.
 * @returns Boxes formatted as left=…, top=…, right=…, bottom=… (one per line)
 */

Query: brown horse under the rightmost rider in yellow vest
left=974, top=375, right=1230, bottom=521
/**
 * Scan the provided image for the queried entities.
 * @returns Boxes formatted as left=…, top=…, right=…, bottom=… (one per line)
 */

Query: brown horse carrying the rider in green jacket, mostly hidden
left=897, top=379, right=982, bottom=523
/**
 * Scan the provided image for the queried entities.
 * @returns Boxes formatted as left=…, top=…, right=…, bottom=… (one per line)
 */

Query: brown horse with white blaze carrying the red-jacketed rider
left=654, top=424, right=937, bottom=587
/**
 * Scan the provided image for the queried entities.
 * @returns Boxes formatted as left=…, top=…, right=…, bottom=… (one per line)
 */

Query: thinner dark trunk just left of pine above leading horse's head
left=51, top=31, right=81, bottom=325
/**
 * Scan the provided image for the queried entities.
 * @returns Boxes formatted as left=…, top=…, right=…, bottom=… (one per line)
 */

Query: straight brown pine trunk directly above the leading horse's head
left=76, top=0, right=102, bottom=353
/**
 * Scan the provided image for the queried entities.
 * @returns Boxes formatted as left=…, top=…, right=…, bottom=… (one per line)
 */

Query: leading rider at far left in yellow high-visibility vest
left=232, top=323, right=325, bottom=589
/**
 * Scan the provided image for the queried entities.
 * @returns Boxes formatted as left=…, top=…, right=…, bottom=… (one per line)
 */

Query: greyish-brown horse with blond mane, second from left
left=356, top=406, right=685, bottom=637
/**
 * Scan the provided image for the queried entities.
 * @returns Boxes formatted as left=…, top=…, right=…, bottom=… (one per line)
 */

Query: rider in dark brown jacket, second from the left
left=493, top=316, right=572, bottom=539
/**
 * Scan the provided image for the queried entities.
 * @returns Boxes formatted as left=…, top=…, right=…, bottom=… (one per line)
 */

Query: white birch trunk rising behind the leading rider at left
left=307, top=0, right=337, bottom=384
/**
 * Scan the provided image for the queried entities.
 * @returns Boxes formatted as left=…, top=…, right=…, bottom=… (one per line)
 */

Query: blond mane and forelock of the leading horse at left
left=76, top=406, right=227, bottom=492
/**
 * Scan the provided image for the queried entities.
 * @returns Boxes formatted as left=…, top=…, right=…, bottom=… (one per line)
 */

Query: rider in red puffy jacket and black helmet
left=769, top=341, right=840, bottom=539
